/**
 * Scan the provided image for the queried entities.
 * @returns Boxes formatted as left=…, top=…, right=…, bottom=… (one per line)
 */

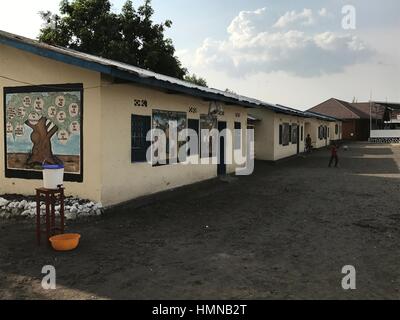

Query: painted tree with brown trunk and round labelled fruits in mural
left=6, top=92, right=81, bottom=166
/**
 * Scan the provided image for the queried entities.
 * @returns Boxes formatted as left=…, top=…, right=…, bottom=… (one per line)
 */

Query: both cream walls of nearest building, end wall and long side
left=0, top=45, right=247, bottom=205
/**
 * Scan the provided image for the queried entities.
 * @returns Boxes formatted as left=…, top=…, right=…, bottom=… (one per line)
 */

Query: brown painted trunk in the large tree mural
left=25, top=117, right=58, bottom=165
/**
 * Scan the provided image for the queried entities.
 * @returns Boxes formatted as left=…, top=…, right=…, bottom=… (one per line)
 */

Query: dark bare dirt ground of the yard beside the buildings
left=0, top=144, right=400, bottom=299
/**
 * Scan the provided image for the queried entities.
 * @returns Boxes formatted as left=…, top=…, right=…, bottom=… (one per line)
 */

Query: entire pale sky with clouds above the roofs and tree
left=0, top=0, right=400, bottom=109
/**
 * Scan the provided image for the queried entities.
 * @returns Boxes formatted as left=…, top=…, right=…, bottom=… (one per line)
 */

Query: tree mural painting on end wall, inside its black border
left=4, top=87, right=82, bottom=180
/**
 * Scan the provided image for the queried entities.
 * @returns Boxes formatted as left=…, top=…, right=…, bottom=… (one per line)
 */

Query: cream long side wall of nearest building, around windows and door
left=99, top=79, right=247, bottom=205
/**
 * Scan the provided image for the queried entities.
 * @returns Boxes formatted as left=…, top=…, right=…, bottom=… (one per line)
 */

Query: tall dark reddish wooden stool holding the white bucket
left=36, top=187, right=65, bottom=245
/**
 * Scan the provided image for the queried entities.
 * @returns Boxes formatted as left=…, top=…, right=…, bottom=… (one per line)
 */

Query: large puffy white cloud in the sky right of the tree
left=191, top=8, right=372, bottom=77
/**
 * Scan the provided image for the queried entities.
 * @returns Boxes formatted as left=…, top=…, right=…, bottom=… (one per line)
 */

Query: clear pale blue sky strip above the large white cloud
left=148, top=0, right=400, bottom=49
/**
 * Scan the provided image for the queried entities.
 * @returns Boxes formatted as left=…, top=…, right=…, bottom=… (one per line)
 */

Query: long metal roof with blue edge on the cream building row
left=0, top=30, right=340, bottom=122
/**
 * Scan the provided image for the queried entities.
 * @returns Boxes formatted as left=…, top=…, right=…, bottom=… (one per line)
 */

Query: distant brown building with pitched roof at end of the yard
left=308, top=98, right=386, bottom=141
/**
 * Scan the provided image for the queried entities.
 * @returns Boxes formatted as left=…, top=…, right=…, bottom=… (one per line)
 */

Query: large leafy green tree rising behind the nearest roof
left=39, top=0, right=187, bottom=79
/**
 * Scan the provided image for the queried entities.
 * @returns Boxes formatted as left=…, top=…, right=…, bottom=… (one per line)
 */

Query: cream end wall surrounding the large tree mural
left=0, top=44, right=104, bottom=201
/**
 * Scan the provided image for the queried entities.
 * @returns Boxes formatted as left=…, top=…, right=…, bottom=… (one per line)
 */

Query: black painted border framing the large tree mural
left=3, top=83, right=84, bottom=182
